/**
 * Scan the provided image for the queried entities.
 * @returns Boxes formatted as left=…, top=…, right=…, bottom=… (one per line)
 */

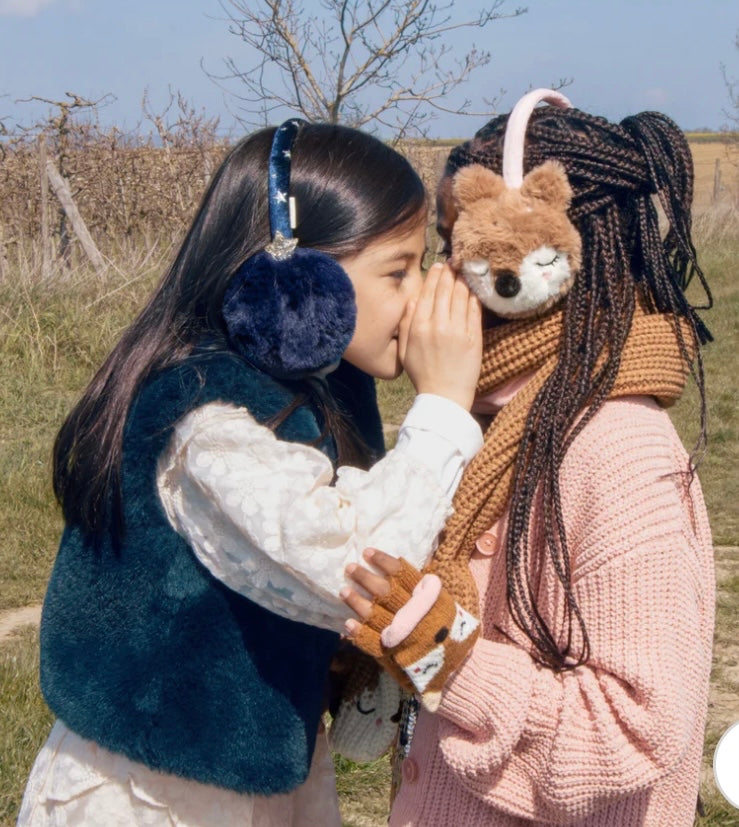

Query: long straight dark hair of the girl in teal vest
left=53, top=124, right=426, bottom=532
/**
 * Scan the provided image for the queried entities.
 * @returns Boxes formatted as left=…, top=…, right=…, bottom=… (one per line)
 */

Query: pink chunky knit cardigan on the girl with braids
left=390, top=397, right=715, bottom=827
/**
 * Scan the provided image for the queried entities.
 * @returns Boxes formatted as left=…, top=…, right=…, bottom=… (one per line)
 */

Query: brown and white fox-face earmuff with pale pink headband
left=451, top=89, right=582, bottom=319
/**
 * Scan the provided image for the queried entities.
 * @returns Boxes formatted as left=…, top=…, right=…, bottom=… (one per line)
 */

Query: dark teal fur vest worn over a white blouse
left=41, top=351, right=382, bottom=795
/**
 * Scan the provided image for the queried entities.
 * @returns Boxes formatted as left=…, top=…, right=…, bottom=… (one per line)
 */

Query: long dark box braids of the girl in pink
left=445, top=106, right=712, bottom=669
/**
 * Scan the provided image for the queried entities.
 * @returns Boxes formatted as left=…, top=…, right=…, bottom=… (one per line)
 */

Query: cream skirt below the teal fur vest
left=18, top=721, right=341, bottom=827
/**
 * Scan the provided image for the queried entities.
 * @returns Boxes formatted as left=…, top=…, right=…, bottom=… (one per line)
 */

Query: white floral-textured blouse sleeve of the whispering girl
left=157, top=394, right=482, bottom=631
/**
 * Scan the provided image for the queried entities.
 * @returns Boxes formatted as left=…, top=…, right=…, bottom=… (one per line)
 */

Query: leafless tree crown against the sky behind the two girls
left=209, top=0, right=526, bottom=137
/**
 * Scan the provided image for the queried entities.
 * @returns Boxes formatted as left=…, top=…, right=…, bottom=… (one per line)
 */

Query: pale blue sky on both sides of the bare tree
left=0, top=0, right=739, bottom=137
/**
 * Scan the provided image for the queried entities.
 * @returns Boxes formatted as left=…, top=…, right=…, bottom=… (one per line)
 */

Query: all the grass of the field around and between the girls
left=0, top=212, right=739, bottom=827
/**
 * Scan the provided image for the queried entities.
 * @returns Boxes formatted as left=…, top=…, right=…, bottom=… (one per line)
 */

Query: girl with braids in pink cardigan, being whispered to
left=344, top=90, right=715, bottom=827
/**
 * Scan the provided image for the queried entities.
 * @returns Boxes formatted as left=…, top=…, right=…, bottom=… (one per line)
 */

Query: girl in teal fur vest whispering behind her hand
left=18, top=121, right=482, bottom=827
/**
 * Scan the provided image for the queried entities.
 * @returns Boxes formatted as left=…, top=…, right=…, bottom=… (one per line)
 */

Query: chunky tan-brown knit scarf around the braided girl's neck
left=428, top=307, right=692, bottom=614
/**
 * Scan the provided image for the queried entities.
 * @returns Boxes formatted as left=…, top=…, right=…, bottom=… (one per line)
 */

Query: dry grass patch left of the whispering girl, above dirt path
left=0, top=268, right=165, bottom=609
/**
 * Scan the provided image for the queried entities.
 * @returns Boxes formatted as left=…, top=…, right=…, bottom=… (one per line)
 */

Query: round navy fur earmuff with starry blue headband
left=223, top=119, right=357, bottom=379
